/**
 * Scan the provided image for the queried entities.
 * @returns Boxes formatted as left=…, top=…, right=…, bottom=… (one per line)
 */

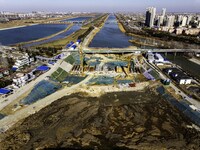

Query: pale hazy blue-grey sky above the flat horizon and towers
left=0, top=0, right=200, bottom=12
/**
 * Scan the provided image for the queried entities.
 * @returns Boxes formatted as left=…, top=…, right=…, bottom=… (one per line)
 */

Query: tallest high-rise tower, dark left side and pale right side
left=145, top=7, right=156, bottom=27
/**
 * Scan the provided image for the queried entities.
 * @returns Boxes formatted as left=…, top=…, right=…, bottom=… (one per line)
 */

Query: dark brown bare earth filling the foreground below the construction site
left=0, top=90, right=200, bottom=150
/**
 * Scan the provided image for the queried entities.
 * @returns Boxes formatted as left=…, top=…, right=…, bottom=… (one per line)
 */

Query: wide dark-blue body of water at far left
left=0, top=24, right=67, bottom=45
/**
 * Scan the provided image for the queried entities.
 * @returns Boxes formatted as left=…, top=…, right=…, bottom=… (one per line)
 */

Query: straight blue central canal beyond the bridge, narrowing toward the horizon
left=89, top=15, right=132, bottom=48
